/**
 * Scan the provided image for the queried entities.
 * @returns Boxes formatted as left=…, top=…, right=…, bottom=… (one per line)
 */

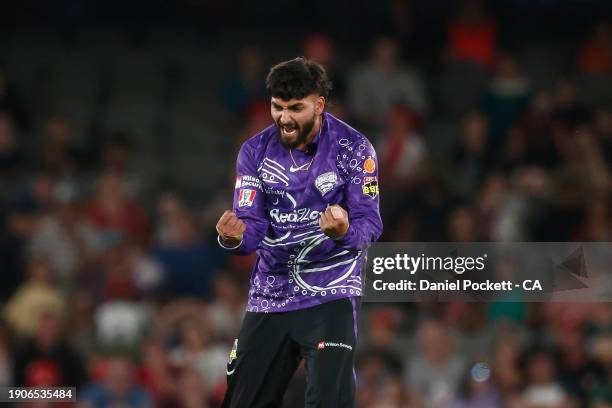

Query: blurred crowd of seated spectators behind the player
left=0, top=0, right=612, bottom=408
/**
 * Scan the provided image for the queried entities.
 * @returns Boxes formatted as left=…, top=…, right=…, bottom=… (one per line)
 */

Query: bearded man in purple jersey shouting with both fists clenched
left=217, top=58, right=382, bottom=408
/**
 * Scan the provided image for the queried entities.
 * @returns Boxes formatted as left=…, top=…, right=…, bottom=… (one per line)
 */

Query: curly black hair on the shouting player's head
left=266, top=57, right=332, bottom=101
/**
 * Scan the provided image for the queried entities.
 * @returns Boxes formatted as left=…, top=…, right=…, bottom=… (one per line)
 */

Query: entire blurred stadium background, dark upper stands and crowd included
left=0, top=0, right=612, bottom=408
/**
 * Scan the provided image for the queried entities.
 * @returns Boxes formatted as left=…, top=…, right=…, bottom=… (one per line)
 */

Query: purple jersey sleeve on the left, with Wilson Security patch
left=218, top=143, right=269, bottom=255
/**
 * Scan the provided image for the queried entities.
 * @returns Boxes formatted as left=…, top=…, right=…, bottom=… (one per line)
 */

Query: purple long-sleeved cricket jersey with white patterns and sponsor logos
left=220, top=113, right=382, bottom=312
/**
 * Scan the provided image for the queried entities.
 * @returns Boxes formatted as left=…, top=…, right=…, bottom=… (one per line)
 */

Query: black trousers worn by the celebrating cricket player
left=222, top=298, right=360, bottom=408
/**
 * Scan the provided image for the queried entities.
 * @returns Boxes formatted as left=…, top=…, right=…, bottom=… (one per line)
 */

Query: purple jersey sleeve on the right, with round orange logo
left=336, top=138, right=383, bottom=250
